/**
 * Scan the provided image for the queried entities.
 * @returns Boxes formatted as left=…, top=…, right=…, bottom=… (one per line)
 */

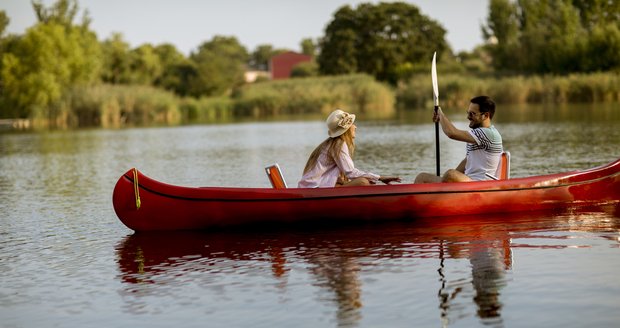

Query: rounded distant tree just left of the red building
left=189, top=36, right=249, bottom=97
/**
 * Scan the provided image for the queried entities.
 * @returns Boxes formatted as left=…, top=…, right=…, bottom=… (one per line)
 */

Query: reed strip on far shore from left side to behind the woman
left=19, top=75, right=395, bottom=129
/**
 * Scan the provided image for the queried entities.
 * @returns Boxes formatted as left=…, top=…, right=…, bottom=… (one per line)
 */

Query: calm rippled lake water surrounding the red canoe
left=0, top=104, right=620, bottom=327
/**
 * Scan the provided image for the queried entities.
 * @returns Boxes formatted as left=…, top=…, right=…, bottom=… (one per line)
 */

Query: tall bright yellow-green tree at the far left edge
left=0, top=0, right=101, bottom=119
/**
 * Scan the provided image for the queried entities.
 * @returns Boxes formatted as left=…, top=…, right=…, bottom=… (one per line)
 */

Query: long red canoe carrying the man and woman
left=112, top=159, right=620, bottom=231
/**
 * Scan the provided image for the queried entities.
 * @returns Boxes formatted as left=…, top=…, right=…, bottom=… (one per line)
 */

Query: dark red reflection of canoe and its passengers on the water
left=117, top=206, right=620, bottom=326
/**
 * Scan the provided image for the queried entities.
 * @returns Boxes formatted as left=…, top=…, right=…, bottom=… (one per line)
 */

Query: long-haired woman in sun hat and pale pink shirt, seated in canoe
left=297, top=109, right=400, bottom=188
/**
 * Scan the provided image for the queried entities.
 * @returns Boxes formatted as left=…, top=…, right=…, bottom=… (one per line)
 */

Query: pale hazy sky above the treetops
left=0, top=0, right=489, bottom=55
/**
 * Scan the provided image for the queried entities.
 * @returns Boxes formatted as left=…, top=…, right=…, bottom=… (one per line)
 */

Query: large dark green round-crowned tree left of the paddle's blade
left=317, top=2, right=450, bottom=84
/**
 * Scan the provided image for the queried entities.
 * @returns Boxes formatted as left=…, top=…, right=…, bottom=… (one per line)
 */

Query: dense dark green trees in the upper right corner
left=483, top=0, right=620, bottom=74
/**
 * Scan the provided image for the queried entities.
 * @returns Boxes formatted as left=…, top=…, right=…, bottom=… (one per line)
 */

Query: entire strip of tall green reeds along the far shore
left=5, top=73, right=620, bottom=129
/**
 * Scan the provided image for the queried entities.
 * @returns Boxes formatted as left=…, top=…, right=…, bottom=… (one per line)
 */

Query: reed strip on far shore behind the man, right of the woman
left=397, top=73, right=620, bottom=109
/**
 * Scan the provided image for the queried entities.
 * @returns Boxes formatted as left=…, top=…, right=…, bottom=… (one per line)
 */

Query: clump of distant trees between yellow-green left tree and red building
left=101, top=34, right=248, bottom=97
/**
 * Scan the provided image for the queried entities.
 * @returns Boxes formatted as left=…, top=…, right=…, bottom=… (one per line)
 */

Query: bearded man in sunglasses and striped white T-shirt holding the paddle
left=415, top=96, right=503, bottom=183
